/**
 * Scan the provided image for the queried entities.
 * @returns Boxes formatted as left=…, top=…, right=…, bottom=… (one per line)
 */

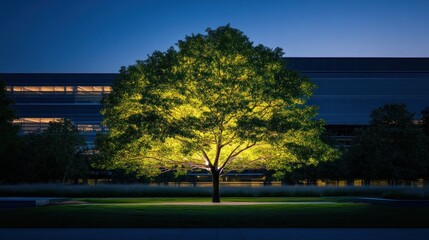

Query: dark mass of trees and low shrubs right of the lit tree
left=285, top=104, right=429, bottom=185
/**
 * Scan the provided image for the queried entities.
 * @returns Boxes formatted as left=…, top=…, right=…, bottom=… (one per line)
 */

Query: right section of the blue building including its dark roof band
left=287, top=58, right=429, bottom=125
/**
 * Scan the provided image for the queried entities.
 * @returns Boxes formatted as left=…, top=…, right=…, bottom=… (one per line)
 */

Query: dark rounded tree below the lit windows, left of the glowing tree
left=23, top=119, right=88, bottom=182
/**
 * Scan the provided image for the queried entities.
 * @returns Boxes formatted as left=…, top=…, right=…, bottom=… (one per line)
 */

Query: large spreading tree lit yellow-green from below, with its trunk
left=99, top=25, right=334, bottom=202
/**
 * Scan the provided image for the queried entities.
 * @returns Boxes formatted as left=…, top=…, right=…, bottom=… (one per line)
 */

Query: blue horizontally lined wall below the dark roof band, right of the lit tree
left=308, top=73, right=429, bottom=125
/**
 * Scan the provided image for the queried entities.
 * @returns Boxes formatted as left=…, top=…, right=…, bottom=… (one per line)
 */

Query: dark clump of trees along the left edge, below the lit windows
left=0, top=82, right=88, bottom=183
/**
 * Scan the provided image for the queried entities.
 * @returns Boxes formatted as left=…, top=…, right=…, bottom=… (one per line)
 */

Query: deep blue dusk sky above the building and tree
left=0, top=0, right=429, bottom=73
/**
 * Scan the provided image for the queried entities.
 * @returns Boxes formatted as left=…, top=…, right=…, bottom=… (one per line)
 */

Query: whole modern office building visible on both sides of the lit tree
left=0, top=58, right=429, bottom=146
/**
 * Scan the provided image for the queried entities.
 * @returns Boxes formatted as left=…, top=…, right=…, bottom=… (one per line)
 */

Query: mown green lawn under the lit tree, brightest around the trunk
left=0, top=197, right=429, bottom=228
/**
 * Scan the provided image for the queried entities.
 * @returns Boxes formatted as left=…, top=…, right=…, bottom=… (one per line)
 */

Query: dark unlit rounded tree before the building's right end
left=347, top=104, right=429, bottom=183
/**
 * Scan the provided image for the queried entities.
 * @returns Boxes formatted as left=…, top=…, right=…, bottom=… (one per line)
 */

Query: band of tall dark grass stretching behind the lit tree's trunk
left=0, top=184, right=429, bottom=199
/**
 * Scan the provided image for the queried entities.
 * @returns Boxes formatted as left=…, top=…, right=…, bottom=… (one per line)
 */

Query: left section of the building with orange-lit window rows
left=0, top=74, right=116, bottom=147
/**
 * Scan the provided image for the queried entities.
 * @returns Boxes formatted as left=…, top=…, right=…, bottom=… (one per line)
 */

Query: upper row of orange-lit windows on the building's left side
left=6, top=86, right=112, bottom=94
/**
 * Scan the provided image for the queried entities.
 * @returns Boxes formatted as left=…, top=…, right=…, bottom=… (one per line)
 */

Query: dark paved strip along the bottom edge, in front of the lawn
left=0, top=228, right=429, bottom=240
